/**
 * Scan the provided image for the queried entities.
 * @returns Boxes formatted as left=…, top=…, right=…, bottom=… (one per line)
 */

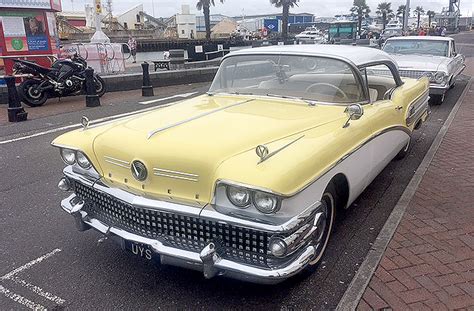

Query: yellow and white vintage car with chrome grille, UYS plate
left=52, top=45, right=429, bottom=284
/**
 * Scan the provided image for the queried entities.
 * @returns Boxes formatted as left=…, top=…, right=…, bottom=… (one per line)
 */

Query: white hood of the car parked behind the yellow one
left=390, top=54, right=449, bottom=71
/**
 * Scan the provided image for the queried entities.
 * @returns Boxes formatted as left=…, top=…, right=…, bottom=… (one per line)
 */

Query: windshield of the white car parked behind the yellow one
left=383, top=40, right=449, bottom=56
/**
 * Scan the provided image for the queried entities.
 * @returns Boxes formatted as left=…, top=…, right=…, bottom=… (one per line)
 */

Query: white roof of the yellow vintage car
left=225, top=44, right=396, bottom=66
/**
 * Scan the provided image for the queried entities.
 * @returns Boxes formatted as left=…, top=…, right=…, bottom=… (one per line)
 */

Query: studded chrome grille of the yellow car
left=75, top=182, right=272, bottom=267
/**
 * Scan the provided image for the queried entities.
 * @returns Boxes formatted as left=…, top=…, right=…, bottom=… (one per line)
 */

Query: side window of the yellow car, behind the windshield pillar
left=364, top=65, right=397, bottom=102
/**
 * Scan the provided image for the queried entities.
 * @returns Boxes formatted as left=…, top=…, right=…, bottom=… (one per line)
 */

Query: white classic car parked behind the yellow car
left=383, top=36, right=466, bottom=104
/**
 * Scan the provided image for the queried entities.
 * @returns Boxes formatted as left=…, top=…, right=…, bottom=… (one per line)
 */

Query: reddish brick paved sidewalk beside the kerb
left=357, top=80, right=474, bottom=310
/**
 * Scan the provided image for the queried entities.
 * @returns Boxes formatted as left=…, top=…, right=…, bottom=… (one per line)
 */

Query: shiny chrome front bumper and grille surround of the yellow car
left=57, top=170, right=321, bottom=284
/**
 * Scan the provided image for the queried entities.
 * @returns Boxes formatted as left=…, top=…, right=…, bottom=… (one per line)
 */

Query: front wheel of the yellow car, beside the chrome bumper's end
left=309, top=183, right=338, bottom=266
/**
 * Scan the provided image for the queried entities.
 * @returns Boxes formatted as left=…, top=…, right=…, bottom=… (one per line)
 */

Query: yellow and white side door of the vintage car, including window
left=366, top=65, right=410, bottom=182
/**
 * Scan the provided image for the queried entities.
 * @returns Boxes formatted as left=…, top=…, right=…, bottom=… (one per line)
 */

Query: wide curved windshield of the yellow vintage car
left=209, top=55, right=363, bottom=103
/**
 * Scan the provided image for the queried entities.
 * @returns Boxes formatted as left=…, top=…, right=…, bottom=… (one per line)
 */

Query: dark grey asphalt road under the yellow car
left=0, top=39, right=467, bottom=310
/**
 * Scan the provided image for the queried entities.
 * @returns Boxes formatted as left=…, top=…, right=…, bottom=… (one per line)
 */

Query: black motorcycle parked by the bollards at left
left=13, top=55, right=106, bottom=107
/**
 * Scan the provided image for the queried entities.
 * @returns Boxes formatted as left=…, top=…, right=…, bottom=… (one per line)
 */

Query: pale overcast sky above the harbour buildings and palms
left=62, top=0, right=474, bottom=17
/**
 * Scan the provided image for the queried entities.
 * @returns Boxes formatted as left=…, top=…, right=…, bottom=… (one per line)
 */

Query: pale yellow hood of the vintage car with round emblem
left=85, top=95, right=345, bottom=205
